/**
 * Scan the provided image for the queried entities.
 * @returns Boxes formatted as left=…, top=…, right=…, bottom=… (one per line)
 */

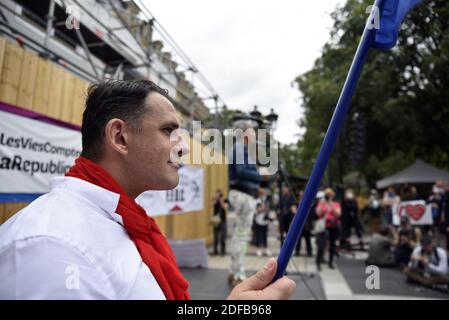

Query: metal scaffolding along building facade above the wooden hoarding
left=0, top=0, right=225, bottom=119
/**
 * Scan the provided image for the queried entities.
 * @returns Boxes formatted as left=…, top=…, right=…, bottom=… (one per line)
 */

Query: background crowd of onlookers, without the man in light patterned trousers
left=214, top=181, right=449, bottom=290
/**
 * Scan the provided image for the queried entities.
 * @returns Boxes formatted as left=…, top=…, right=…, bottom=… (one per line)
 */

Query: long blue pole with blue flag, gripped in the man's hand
left=273, top=0, right=419, bottom=282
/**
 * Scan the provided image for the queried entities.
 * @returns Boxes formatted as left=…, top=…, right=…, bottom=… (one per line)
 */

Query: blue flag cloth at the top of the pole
left=373, top=0, right=422, bottom=50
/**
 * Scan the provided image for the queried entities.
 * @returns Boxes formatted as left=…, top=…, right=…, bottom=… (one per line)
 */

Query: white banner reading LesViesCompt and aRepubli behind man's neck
left=0, top=111, right=81, bottom=193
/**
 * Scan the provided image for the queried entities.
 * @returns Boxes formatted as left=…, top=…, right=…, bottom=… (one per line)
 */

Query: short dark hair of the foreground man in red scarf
left=81, top=80, right=168, bottom=160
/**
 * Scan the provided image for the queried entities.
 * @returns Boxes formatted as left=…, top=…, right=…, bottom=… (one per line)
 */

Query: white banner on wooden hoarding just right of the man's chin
left=136, top=166, right=204, bottom=216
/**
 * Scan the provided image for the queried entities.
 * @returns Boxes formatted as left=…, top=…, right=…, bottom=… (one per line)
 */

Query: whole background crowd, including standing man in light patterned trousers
left=212, top=104, right=449, bottom=294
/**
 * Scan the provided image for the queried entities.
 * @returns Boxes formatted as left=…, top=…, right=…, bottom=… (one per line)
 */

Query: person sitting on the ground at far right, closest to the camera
left=404, top=234, right=449, bottom=287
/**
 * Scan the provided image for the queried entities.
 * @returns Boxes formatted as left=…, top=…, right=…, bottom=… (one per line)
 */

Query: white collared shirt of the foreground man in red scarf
left=0, top=177, right=165, bottom=299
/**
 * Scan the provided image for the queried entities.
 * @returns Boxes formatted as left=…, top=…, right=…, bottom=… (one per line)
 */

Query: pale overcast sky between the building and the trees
left=144, top=0, right=345, bottom=144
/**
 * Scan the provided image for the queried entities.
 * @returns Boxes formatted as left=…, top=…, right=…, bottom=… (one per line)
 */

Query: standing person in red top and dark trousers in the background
left=316, top=188, right=341, bottom=271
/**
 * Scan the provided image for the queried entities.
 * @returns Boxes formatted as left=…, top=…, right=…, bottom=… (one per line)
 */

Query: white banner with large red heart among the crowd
left=393, top=200, right=433, bottom=226
